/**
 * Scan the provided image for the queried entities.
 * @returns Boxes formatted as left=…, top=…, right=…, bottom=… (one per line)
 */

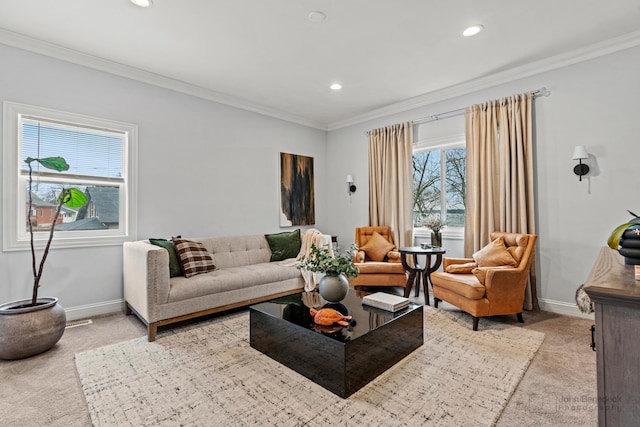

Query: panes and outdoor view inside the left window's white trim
left=21, top=118, right=124, bottom=231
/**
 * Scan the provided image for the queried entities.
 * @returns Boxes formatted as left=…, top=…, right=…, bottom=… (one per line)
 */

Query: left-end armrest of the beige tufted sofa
left=122, top=241, right=169, bottom=322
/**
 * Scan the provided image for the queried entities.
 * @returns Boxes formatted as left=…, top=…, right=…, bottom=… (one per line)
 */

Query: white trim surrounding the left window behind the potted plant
left=2, top=101, right=138, bottom=251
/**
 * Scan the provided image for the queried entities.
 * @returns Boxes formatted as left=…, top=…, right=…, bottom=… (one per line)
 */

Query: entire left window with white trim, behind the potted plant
left=2, top=102, right=137, bottom=250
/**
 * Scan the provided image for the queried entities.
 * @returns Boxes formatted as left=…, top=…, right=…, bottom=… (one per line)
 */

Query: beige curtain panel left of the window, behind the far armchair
left=369, top=122, right=413, bottom=247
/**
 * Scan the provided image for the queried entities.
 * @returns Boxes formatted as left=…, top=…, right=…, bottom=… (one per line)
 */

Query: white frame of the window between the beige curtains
left=411, top=134, right=466, bottom=240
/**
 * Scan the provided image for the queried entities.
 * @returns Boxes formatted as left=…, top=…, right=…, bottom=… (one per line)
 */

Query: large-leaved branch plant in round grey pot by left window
left=0, top=157, right=87, bottom=360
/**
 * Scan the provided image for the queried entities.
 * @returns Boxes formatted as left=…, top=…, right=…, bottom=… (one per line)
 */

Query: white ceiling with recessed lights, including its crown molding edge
left=0, top=0, right=640, bottom=129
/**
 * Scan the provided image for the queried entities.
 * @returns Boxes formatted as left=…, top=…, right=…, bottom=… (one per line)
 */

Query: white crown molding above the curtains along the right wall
left=328, top=31, right=640, bottom=131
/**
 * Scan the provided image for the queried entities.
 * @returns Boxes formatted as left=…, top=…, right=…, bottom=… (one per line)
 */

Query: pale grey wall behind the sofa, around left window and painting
left=0, top=45, right=328, bottom=311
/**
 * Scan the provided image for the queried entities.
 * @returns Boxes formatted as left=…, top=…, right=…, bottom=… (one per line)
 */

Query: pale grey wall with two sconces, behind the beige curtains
left=327, top=47, right=640, bottom=312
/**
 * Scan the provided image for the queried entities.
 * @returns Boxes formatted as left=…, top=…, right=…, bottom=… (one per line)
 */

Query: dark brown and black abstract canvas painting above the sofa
left=280, top=153, right=316, bottom=227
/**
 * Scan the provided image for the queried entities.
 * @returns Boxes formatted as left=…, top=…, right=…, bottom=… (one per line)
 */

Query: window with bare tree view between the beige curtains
left=413, top=136, right=466, bottom=237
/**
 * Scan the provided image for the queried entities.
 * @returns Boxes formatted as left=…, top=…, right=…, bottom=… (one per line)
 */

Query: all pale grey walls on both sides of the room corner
left=0, top=41, right=640, bottom=320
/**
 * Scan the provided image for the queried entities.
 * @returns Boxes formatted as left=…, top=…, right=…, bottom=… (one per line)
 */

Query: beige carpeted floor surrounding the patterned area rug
left=0, top=297, right=597, bottom=427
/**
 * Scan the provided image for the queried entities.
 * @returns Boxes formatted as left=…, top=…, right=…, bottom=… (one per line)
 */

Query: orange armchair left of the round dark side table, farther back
left=352, top=226, right=407, bottom=287
